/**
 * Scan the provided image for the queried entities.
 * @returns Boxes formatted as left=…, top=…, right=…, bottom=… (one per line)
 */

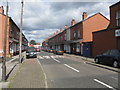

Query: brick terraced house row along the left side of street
left=0, top=6, right=28, bottom=57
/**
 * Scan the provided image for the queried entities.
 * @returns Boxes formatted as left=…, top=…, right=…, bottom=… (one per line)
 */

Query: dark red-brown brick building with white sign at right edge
left=93, top=2, right=120, bottom=57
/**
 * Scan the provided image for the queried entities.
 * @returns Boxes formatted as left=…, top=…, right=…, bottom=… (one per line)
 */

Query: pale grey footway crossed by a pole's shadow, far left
left=0, top=52, right=25, bottom=89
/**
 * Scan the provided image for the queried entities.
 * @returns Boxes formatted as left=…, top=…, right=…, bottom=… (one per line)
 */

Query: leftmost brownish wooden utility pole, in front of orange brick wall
left=2, top=2, right=8, bottom=82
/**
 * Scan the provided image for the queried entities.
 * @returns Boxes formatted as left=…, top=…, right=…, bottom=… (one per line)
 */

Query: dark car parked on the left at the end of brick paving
left=26, top=47, right=37, bottom=58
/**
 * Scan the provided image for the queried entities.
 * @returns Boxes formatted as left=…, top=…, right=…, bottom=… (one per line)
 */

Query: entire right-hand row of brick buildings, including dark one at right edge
left=42, top=2, right=120, bottom=57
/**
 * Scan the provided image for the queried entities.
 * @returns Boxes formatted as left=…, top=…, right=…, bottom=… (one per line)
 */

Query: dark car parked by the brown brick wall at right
left=94, top=50, right=120, bottom=67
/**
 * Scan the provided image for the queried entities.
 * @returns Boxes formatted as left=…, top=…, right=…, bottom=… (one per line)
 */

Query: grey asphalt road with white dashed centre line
left=38, top=52, right=118, bottom=90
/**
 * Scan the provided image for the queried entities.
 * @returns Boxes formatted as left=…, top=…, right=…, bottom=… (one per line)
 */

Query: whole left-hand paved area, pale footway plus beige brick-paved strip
left=0, top=53, right=47, bottom=89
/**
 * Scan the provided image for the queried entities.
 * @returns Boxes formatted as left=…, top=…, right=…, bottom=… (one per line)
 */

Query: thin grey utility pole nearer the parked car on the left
left=19, top=0, right=23, bottom=63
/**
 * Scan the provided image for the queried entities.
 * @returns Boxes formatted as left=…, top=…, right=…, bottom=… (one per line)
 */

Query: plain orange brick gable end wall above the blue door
left=83, top=13, right=109, bottom=42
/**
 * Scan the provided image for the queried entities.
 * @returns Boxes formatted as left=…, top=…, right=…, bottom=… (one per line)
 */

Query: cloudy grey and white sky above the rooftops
left=0, top=0, right=119, bottom=42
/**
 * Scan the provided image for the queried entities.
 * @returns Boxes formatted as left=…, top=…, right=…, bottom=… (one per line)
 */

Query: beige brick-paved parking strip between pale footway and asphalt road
left=9, top=58, right=46, bottom=88
